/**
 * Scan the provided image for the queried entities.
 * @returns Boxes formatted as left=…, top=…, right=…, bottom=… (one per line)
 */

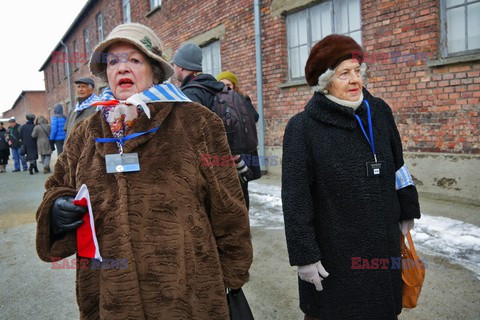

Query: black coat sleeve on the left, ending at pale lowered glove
left=282, top=116, right=322, bottom=266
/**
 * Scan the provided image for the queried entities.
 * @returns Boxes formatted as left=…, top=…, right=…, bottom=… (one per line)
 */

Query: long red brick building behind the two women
left=41, top=0, right=480, bottom=204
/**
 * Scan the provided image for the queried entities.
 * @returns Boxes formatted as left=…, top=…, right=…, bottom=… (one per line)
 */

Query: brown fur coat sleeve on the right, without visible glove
left=201, top=112, right=253, bottom=288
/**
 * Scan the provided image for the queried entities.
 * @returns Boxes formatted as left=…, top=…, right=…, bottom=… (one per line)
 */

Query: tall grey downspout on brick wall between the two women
left=253, top=0, right=266, bottom=171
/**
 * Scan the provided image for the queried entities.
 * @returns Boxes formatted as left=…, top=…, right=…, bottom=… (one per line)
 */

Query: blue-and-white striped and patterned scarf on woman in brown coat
left=92, top=83, right=191, bottom=138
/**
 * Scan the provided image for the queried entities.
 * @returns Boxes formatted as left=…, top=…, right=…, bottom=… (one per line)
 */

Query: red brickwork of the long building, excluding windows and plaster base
left=45, top=0, right=480, bottom=154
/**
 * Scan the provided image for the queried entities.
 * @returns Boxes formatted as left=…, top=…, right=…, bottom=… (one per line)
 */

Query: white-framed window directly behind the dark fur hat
left=285, top=0, right=360, bottom=81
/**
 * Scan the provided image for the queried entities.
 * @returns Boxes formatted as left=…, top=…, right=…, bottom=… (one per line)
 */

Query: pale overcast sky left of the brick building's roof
left=0, top=0, right=87, bottom=115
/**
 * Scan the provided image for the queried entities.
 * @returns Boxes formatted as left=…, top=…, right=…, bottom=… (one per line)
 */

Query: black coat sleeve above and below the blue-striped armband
left=385, top=103, right=420, bottom=220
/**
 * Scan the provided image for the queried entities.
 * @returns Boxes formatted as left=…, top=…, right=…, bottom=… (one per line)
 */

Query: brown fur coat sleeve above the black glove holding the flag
left=36, top=121, right=86, bottom=262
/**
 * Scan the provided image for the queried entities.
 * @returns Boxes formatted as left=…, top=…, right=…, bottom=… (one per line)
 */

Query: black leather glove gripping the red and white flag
left=51, top=196, right=88, bottom=235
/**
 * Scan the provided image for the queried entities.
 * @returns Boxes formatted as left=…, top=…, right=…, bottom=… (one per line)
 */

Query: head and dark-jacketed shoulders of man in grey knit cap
left=173, top=42, right=225, bottom=110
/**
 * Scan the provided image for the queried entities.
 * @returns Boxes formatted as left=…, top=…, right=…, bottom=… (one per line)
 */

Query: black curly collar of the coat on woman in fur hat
left=305, top=88, right=375, bottom=129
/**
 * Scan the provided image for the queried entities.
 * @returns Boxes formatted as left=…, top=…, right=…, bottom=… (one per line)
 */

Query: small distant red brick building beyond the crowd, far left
left=2, top=90, right=50, bottom=124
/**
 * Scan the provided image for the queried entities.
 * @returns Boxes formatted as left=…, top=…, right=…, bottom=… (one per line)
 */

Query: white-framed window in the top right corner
left=440, top=0, right=480, bottom=58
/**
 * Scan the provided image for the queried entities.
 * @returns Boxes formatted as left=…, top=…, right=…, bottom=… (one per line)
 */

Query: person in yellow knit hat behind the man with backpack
left=217, top=71, right=262, bottom=208
